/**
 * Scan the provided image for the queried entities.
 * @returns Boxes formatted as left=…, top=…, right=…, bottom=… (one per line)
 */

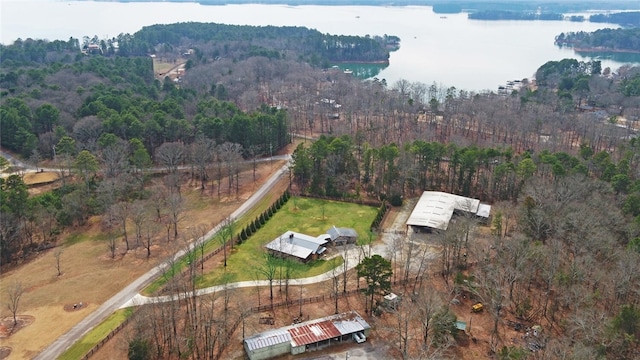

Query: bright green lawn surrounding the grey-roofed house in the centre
left=198, top=197, right=377, bottom=287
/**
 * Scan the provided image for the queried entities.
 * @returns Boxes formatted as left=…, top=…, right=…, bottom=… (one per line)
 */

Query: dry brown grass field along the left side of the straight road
left=0, top=156, right=288, bottom=359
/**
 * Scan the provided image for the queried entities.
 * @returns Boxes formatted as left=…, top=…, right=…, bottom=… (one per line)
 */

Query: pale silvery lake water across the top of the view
left=0, top=0, right=640, bottom=91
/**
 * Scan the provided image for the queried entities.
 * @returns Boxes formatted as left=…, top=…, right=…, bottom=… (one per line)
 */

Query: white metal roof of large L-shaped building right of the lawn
left=407, top=191, right=480, bottom=230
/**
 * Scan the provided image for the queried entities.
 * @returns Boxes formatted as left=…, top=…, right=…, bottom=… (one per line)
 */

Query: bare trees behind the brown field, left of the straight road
left=0, top=131, right=272, bottom=263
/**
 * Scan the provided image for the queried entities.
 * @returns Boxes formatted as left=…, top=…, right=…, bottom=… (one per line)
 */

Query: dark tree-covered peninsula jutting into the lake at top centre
left=118, top=22, right=398, bottom=65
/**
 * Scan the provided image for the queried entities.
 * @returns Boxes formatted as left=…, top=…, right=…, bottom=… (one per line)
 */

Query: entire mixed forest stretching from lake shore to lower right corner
left=0, top=19, right=640, bottom=359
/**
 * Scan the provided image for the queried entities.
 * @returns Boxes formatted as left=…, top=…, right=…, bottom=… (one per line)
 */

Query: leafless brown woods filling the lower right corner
left=458, top=174, right=640, bottom=359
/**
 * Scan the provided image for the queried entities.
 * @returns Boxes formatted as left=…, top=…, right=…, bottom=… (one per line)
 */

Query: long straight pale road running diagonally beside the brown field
left=34, top=157, right=289, bottom=360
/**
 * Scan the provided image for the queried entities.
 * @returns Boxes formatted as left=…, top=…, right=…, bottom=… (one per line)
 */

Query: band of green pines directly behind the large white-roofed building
left=292, top=135, right=639, bottom=212
